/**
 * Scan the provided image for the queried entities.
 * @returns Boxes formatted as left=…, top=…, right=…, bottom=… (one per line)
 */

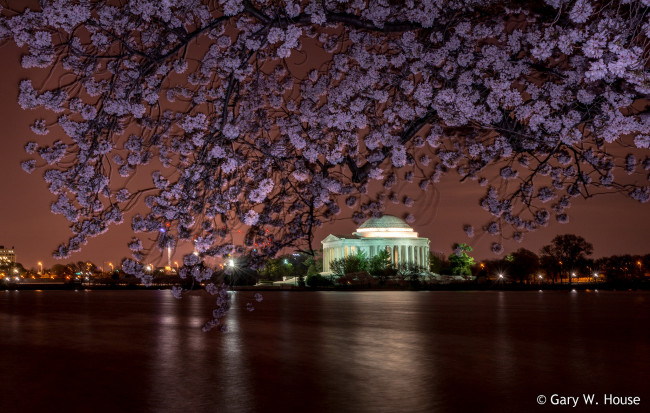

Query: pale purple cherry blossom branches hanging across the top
left=0, top=0, right=650, bottom=284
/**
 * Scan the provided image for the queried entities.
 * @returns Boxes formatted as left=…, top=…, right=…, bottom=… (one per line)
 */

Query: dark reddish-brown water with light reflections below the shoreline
left=0, top=291, right=650, bottom=413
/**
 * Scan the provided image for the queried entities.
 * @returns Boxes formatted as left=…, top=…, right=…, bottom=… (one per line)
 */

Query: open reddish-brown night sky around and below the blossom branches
left=0, top=38, right=650, bottom=268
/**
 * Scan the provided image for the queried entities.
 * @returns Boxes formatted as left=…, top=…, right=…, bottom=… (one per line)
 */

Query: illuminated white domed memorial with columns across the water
left=321, top=215, right=430, bottom=275
